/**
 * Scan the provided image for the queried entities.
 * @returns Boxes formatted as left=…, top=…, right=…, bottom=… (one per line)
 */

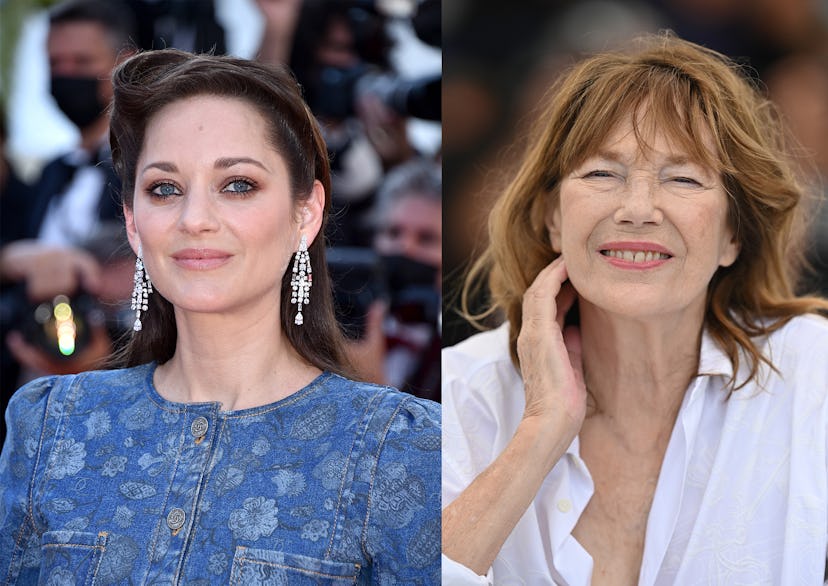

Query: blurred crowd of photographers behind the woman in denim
left=0, top=0, right=442, bottom=437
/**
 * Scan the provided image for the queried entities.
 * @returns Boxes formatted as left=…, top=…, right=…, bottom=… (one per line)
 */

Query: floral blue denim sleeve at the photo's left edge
left=0, top=377, right=57, bottom=584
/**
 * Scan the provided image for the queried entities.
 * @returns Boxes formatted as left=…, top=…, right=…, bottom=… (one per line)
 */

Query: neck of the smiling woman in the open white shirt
left=580, top=299, right=704, bottom=429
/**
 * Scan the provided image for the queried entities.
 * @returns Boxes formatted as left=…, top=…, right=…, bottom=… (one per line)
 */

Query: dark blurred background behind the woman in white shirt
left=443, top=0, right=828, bottom=345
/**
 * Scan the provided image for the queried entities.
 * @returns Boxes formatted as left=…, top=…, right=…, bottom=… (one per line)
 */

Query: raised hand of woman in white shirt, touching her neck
left=517, top=256, right=587, bottom=444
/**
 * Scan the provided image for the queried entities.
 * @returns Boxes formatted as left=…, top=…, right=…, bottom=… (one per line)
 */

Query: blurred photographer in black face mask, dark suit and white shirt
left=0, top=0, right=133, bottom=434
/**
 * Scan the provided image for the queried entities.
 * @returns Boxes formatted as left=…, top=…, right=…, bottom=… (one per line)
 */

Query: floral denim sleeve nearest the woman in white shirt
left=366, top=397, right=441, bottom=585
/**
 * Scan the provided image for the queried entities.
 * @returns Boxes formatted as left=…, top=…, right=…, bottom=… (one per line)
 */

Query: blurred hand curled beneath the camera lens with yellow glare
left=6, top=325, right=112, bottom=375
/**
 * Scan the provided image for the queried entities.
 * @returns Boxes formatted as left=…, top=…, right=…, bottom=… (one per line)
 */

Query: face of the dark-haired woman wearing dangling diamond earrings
left=125, top=96, right=324, bottom=317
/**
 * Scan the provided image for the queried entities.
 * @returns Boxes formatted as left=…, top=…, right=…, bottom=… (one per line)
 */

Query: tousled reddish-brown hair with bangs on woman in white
left=462, top=33, right=828, bottom=390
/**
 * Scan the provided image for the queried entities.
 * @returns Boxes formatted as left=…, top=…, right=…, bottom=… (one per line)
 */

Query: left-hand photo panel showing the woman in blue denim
left=0, top=0, right=442, bottom=585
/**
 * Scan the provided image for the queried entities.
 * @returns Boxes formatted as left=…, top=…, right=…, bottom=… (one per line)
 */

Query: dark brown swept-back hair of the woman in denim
left=110, top=49, right=348, bottom=374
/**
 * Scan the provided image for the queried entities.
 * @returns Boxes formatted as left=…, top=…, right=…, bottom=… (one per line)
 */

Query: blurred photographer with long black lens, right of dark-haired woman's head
left=284, top=0, right=440, bottom=247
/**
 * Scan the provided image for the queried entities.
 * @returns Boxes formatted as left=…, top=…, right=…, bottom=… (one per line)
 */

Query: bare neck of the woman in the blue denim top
left=155, top=303, right=320, bottom=411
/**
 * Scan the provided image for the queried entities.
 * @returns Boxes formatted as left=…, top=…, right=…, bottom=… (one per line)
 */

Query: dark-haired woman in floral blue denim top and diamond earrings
left=0, top=50, right=440, bottom=585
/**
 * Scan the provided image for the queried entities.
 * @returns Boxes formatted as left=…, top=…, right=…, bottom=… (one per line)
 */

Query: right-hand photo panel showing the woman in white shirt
left=442, top=0, right=828, bottom=586
